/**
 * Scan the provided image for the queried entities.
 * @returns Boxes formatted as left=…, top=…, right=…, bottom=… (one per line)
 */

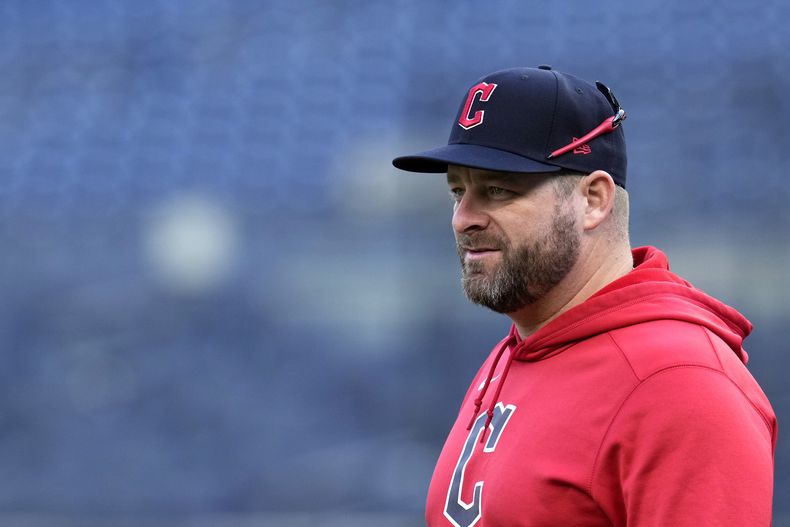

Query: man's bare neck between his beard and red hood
left=508, top=246, right=633, bottom=338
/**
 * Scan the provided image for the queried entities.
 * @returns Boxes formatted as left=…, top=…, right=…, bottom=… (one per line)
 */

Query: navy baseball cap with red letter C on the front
left=392, top=66, right=627, bottom=188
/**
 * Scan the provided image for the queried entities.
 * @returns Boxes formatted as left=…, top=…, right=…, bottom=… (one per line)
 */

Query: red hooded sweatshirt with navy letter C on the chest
left=426, top=247, right=777, bottom=527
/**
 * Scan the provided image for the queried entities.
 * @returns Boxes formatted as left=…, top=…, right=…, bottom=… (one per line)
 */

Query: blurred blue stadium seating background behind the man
left=0, top=0, right=790, bottom=527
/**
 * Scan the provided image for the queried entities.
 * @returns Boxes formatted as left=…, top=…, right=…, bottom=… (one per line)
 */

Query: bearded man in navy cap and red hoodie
left=393, top=66, right=777, bottom=527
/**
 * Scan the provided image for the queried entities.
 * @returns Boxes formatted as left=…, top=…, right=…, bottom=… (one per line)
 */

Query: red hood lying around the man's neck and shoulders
left=511, top=247, right=752, bottom=364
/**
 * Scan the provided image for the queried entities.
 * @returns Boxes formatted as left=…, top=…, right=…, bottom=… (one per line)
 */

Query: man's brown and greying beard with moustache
left=456, top=206, right=581, bottom=313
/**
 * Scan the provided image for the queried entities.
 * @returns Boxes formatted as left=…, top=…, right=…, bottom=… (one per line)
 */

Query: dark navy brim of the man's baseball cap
left=392, top=144, right=562, bottom=174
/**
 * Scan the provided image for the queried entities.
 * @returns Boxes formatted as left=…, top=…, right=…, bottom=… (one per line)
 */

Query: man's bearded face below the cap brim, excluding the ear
left=447, top=166, right=581, bottom=313
